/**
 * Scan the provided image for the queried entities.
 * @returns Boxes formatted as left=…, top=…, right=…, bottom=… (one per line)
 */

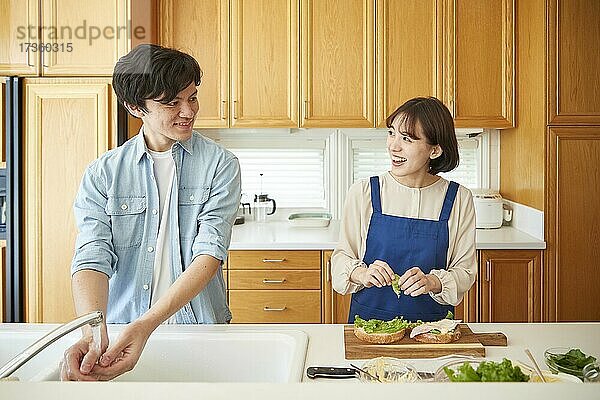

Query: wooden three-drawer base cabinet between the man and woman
left=228, top=250, right=322, bottom=323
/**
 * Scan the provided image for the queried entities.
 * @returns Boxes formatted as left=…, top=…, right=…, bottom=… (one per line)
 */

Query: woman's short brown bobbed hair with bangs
left=385, top=97, right=459, bottom=175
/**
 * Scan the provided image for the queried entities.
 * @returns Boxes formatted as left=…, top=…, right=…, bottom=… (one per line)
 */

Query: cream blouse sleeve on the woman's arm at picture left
left=331, top=182, right=369, bottom=294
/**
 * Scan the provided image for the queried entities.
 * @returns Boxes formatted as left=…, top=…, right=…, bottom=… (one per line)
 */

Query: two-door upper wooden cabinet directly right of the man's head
left=160, top=0, right=299, bottom=128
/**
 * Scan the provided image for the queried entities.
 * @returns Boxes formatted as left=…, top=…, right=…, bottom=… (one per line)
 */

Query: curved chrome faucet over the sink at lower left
left=0, top=311, right=104, bottom=379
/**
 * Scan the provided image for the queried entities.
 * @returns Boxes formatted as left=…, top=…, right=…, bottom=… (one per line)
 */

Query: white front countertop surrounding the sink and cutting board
left=0, top=323, right=600, bottom=400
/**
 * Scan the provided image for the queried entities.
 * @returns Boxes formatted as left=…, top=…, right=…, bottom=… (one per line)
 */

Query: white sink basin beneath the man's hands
left=0, top=325, right=308, bottom=383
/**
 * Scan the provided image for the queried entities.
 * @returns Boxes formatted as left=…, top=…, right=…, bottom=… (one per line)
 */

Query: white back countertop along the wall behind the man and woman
left=229, top=220, right=546, bottom=250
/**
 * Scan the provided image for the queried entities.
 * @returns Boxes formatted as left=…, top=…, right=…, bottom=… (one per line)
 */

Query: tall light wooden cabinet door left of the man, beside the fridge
left=23, top=78, right=117, bottom=322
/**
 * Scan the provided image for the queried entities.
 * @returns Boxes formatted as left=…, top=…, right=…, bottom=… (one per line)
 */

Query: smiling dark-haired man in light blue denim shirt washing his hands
left=61, top=45, right=241, bottom=380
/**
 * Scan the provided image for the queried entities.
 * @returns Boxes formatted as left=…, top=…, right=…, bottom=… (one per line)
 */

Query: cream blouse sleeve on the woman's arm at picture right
left=430, top=186, right=477, bottom=306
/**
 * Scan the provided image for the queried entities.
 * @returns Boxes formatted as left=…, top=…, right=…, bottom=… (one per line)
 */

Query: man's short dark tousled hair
left=113, top=44, right=202, bottom=112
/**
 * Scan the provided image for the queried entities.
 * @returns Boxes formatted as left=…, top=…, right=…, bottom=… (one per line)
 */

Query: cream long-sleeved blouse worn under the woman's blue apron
left=331, top=172, right=477, bottom=305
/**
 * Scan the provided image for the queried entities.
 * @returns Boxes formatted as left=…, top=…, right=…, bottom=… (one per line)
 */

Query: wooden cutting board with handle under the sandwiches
left=344, top=324, right=507, bottom=360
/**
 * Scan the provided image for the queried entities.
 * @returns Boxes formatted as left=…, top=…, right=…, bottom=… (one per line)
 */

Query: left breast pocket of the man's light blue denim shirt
left=105, top=196, right=147, bottom=249
